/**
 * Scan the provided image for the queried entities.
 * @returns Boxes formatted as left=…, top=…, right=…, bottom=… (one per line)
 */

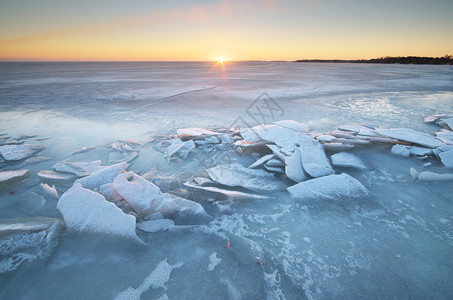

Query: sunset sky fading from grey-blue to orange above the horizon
left=0, top=0, right=453, bottom=61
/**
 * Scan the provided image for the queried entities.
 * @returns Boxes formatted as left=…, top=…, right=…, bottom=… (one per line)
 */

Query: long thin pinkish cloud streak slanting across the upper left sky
left=0, top=0, right=278, bottom=46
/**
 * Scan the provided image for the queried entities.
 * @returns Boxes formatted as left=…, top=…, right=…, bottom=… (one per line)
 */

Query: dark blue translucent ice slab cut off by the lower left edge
left=0, top=217, right=64, bottom=273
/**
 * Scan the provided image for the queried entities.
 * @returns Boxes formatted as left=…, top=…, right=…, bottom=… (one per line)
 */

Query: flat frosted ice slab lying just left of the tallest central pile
left=206, top=164, right=286, bottom=192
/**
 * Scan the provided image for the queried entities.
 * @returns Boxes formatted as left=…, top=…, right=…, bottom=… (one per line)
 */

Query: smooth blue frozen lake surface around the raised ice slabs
left=0, top=63, right=453, bottom=299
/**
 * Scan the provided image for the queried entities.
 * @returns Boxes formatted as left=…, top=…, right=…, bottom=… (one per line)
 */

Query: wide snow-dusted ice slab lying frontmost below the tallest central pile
left=287, top=173, right=368, bottom=199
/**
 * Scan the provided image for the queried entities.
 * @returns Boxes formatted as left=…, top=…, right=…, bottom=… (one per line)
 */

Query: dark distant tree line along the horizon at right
left=296, top=55, right=453, bottom=65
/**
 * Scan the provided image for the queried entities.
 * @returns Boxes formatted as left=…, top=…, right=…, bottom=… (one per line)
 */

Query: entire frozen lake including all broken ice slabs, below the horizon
left=0, top=63, right=453, bottom=299
